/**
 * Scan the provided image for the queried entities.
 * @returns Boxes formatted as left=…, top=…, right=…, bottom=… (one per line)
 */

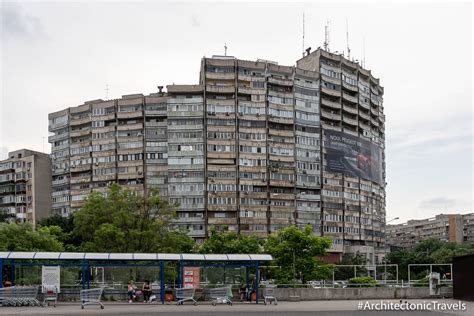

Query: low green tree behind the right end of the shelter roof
left=199, top=227, right=263, bottom=254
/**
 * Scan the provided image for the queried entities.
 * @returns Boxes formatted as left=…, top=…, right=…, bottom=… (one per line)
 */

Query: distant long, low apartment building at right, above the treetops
left=386, top=214, right=464, bottom=248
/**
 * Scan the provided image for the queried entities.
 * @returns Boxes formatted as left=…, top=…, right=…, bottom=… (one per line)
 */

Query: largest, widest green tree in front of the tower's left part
left=73, top=184, right=193, bottom=252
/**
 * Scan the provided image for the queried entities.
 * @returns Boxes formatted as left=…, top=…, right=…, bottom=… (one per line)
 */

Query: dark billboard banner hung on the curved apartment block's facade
left=325, top=130, right=383, bottom=185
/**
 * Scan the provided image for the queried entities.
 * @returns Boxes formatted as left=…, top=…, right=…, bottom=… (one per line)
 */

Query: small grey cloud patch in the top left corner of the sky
left=0, top=2, right=45, bottom=39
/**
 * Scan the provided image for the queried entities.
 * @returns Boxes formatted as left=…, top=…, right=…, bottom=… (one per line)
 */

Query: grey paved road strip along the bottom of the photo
left=0, top=300, right=474, bottom=316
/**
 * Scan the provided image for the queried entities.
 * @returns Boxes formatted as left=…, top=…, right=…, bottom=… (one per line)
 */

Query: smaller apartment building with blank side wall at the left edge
left=0, top=149, right=51, bottom=225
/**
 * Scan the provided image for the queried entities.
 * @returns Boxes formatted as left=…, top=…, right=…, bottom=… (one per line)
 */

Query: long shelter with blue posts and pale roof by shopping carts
left=0, top=252, right=272, bottom=304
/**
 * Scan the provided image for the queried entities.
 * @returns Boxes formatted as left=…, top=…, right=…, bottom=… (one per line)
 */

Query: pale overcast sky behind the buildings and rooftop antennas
left=0, top=1, right=473, bottom=223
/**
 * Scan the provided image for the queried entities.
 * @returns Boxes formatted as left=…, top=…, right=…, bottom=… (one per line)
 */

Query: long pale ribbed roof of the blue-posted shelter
left=0, top=251, right=273, bottom=262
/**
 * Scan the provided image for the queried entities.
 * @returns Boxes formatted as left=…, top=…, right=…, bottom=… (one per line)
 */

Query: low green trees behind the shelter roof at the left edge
left=0, top=223, right=64, bottom=251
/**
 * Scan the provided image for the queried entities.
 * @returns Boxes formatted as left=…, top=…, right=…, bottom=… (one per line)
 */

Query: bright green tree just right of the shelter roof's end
left=264, top=225, right=332, bottom=283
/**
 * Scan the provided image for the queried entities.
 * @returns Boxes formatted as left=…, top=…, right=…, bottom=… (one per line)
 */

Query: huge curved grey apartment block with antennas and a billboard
left=49, top=49, right=385, bottom=260
